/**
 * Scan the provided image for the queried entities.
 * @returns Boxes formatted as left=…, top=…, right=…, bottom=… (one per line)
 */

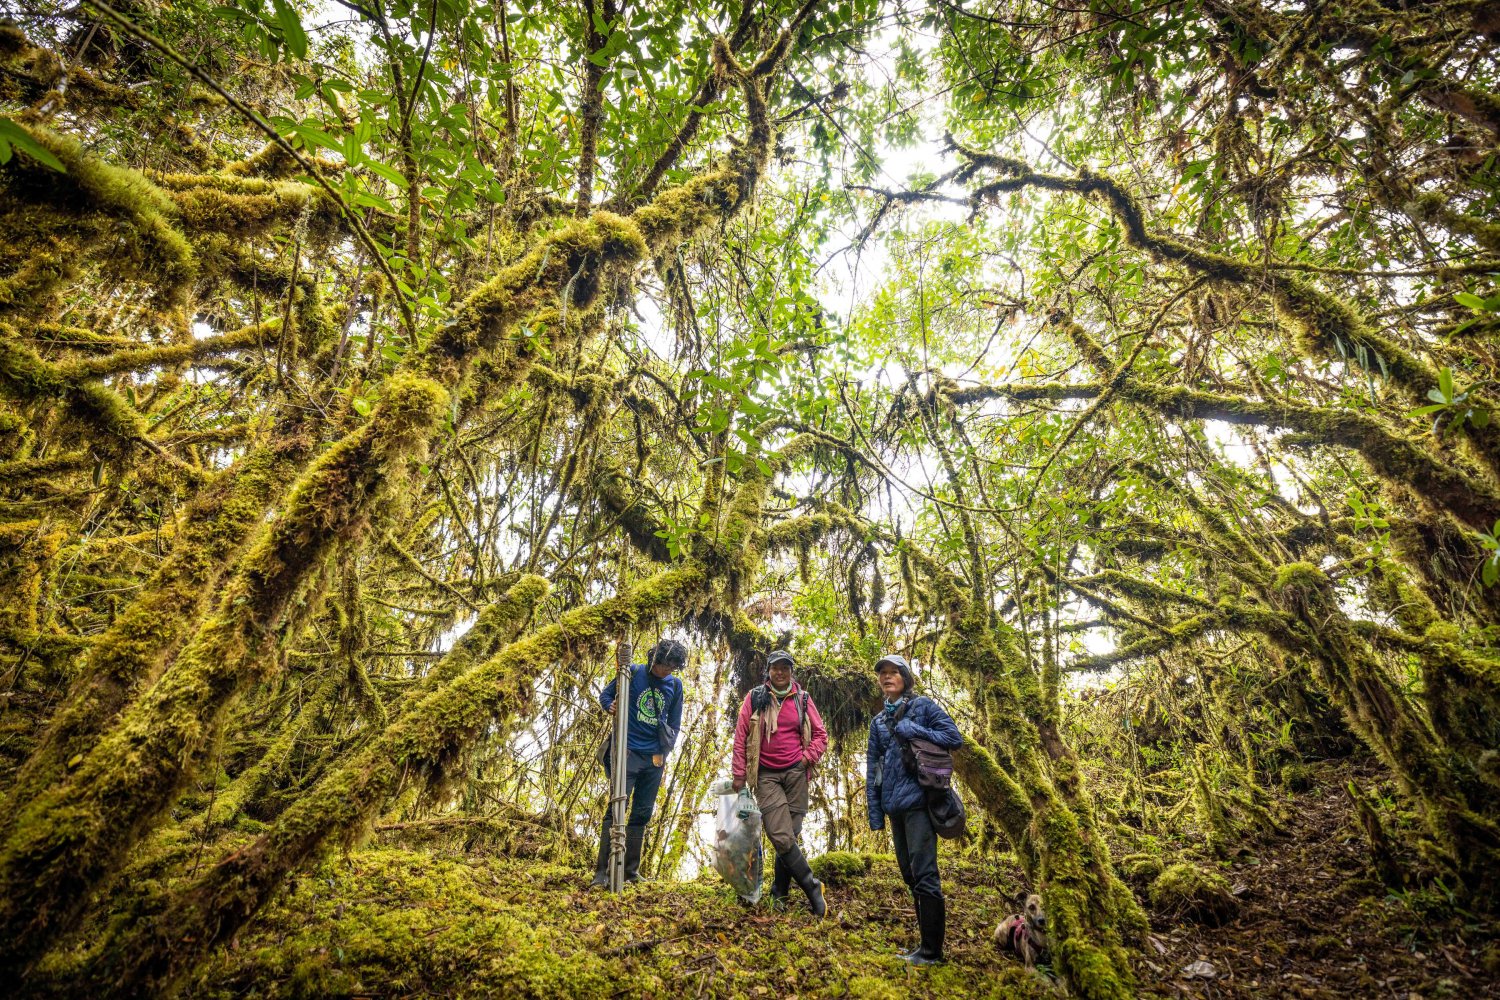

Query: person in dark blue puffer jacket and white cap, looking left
left=864, top=654, right=963, bottom=966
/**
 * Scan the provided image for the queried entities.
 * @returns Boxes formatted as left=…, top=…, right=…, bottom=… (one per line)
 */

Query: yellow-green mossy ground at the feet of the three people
left=185, top=849, right=1058, bottom=1000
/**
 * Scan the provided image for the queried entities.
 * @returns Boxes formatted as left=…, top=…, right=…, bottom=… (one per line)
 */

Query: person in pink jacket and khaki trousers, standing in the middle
left=734, top=649, right=828, bottom=916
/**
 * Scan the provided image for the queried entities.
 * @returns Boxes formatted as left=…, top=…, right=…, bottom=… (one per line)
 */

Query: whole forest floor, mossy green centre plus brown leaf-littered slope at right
left=189, top=765, right=1500, bottom=1000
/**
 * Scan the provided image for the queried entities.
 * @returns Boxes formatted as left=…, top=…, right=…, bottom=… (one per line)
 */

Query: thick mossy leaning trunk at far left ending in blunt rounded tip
left=0, top=375, right=447, bottom=961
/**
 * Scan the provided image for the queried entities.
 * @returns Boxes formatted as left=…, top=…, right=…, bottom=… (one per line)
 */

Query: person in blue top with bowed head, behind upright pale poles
left=593, top=639, right=687, bottom=889
